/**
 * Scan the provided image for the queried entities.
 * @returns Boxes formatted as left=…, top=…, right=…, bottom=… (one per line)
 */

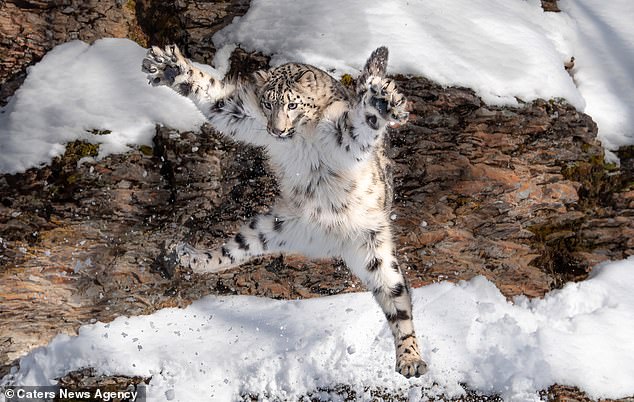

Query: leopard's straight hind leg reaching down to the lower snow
left=343, top=229, right=427, bottom=378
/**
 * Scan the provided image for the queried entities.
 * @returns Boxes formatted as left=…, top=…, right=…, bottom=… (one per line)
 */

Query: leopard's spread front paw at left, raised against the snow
left=141, top=45, right=189, bottom=87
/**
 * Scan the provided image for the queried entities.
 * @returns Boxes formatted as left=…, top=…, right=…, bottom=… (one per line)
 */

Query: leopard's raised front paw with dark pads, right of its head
left=363, top=76, right=409, bottom=129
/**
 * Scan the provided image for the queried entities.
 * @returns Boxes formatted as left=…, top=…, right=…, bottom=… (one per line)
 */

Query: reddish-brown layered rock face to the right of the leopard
left=392, top=78, right=634, bottom=296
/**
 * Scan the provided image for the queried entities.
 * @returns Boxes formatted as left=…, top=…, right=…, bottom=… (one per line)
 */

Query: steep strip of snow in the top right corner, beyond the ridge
left=560, top=0, right=634, bottom=149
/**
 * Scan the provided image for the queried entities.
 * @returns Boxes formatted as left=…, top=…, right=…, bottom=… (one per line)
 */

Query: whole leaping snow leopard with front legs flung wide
left=142, top=45, right=427, bottom=378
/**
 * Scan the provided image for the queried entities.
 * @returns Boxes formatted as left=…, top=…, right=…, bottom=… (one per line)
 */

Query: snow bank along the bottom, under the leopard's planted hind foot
left=0, top=257, right=634, bottom=401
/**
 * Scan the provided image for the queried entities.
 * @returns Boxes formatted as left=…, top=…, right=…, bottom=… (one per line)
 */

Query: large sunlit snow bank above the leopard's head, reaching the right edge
left=213, top=0, right=634, bottom=150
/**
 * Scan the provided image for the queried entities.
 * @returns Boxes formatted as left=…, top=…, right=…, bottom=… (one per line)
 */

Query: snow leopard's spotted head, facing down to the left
left=255, top=64, right=332, bottom=138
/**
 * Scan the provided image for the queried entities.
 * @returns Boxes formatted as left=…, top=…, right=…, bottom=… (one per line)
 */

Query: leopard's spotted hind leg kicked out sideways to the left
left=176, top=209, right=310, bottom=273
